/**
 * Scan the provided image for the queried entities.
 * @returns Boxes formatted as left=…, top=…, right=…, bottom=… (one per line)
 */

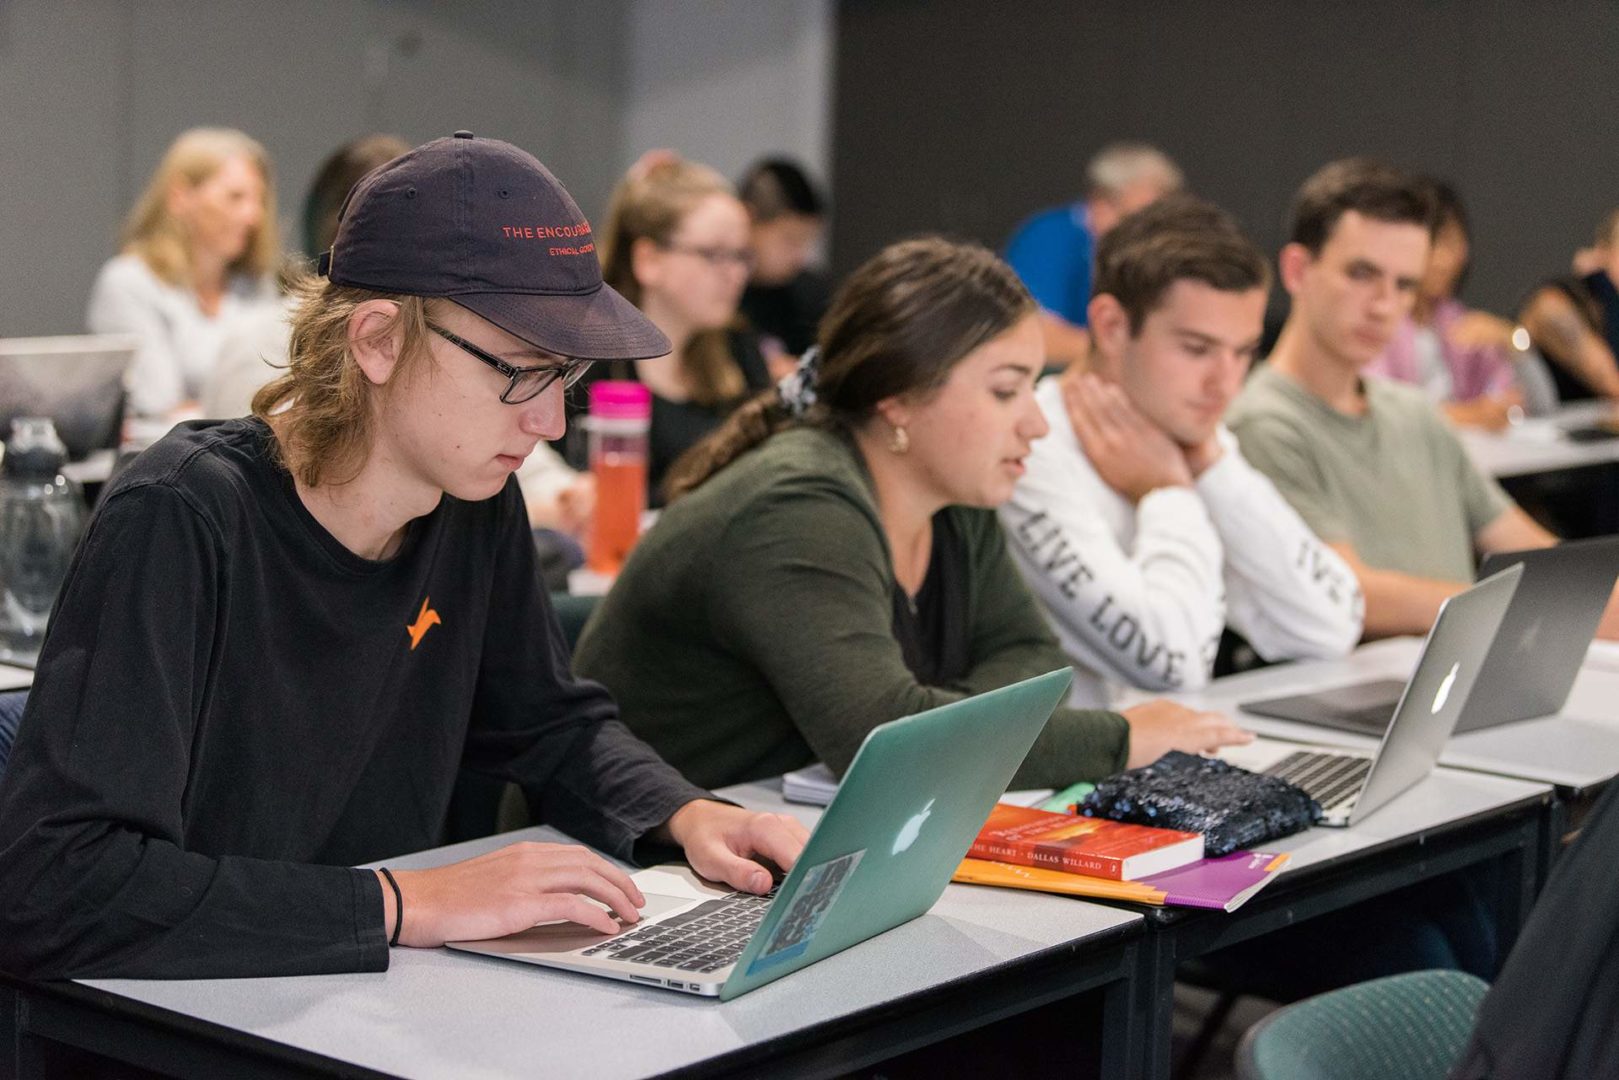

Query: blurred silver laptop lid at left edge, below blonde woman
left=0, top=335, right=134, bottom=461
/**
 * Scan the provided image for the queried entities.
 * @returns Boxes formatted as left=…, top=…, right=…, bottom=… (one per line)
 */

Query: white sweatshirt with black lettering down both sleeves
left=1001, top=379, right=1363, bottom=708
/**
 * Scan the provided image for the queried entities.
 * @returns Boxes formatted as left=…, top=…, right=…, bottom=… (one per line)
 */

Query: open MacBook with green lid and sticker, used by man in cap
left=448, top=669, right=1073, bottom=1001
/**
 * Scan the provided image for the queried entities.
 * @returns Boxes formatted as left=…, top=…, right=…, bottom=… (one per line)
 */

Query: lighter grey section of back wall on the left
left=0, top=0, right=834, bottom=337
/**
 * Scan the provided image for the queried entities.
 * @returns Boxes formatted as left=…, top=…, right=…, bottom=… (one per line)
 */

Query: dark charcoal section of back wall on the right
left=832, top=0, right=1619, bottom=317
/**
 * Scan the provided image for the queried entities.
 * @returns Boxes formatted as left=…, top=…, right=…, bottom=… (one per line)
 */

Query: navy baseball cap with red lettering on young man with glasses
left=319, top=131, right=670, bottom=359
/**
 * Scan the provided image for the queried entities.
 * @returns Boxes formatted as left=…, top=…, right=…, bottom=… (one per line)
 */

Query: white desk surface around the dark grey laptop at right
left=1139, top=638, right=1619, bottom=793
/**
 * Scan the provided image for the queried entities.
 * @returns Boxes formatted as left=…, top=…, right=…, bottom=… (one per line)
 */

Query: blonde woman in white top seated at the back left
left=86, top=128, right=280, bottom=418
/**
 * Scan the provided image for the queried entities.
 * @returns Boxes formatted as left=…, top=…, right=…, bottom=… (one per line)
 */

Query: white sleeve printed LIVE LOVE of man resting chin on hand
left=1001, top=381, right=1226, bottom=706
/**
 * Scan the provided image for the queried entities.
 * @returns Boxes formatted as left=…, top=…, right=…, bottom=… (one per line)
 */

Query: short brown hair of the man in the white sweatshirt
left=1091, top=194, right=1271, bottom=334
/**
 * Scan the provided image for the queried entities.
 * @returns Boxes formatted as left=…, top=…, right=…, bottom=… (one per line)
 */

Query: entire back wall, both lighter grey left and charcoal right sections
left=9, top=0, right=1619, bottom=337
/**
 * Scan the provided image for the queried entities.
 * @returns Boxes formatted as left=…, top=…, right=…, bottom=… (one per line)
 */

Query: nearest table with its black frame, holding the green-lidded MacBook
left=0, top=822, right=1145, bottom=1080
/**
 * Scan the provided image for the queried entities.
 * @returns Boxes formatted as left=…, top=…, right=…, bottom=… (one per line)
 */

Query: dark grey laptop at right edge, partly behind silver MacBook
left=1243, top=536, right=1619, bottom=735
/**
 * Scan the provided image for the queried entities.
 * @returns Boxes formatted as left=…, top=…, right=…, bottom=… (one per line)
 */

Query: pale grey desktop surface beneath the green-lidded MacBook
left=76, top=809, right=1141, bottom=1080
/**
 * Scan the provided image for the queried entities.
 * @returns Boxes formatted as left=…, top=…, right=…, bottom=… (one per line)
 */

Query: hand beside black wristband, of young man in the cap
left=377, top=844, right=646, bottom=949
